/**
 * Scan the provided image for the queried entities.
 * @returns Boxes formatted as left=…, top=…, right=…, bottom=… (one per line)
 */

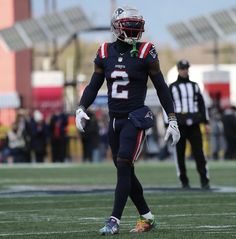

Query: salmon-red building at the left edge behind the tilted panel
left=0, top=0, right=32, bottom=125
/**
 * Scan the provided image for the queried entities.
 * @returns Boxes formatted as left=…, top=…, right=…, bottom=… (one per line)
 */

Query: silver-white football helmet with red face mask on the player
left=111, top=6, right=145, bottom=44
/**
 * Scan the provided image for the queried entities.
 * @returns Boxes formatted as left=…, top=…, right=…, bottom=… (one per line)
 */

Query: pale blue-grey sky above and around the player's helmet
left=32, top=0, right=236, bottom=46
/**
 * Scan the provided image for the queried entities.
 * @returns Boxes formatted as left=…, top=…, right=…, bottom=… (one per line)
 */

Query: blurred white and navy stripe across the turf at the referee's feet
left=0, top=185, right=236, bottom=196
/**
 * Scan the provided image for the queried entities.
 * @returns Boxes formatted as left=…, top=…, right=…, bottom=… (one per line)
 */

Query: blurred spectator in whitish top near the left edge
left=6, top=122, right=26, bottom=163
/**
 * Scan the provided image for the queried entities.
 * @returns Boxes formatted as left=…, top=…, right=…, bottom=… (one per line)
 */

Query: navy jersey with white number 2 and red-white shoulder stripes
left=94, top=42, right=158, bottom=115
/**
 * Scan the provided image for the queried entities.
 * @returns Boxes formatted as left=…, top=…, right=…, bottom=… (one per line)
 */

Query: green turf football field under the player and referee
left=0, top=161, right=236, bottom=239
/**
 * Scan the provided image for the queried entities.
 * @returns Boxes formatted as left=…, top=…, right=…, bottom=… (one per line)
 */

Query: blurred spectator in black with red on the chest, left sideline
left=49, top=112, right=67, bottom=163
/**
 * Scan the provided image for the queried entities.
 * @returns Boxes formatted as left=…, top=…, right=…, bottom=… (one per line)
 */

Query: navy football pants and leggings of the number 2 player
left=109, top=118, right=150, bottom=219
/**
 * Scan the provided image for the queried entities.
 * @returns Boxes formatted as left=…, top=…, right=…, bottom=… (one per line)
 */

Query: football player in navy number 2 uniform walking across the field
left=76, top=6, right=180, bottom=235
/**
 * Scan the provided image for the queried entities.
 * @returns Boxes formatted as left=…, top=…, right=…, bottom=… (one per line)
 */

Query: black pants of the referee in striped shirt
left=176, top=124, right=209, bottom=187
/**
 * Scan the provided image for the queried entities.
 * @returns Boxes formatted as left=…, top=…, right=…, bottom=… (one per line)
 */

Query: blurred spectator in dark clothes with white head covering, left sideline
left=31, top=110, right=48, bottom=163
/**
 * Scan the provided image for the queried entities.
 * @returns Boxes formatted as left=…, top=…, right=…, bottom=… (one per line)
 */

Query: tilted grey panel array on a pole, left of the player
left=0, top=3, right=110, bottom=113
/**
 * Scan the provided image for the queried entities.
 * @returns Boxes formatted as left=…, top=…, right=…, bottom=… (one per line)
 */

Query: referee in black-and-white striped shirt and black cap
left=169, top=60, right=210, bottom=189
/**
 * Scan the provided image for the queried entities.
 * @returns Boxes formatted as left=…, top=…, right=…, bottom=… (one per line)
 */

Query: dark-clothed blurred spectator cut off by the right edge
left=222, top=106, right=236, bottom=159
